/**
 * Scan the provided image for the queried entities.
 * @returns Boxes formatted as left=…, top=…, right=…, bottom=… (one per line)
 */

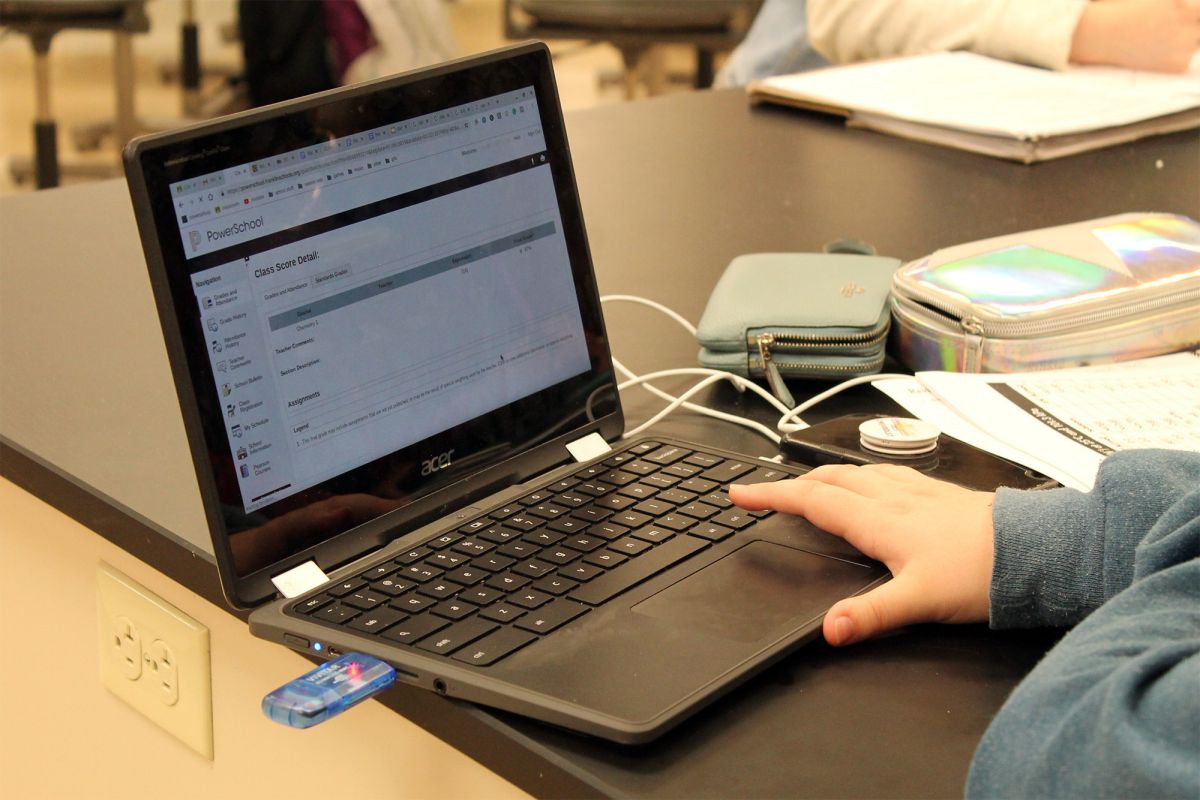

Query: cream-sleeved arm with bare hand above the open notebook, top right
left=796, top=0, right=1200, bottom=73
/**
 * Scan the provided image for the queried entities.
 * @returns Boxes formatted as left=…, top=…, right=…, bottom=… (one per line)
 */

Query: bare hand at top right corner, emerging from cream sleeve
left=1069, top=0, right=1200, bottom=72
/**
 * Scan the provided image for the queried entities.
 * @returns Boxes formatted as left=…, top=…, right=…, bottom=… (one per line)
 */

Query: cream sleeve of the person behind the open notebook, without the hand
left=809, top=0, right=1087, bottom=70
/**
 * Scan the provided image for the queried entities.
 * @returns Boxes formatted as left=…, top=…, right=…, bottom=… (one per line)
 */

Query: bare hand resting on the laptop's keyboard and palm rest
left=730, top=464, right=995, bottom=645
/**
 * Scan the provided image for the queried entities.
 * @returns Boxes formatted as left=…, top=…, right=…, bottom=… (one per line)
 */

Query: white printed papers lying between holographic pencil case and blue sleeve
left=876, top=353, right=1200, bottom=491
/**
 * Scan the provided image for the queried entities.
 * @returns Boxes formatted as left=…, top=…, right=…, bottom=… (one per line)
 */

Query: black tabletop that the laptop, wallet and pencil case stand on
left=0, top=92, right=1200, bottom=798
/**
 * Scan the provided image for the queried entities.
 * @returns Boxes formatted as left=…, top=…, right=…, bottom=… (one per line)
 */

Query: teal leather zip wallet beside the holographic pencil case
left=696, top=253, right=900, bottom=407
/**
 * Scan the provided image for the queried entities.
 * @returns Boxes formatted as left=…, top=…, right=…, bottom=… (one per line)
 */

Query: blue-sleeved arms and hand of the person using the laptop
left=730, top=450, right=1200, bottom=799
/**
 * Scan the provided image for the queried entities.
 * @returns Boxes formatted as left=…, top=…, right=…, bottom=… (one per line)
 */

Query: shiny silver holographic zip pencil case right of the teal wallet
left=888, top=213, right=1200, bottom=372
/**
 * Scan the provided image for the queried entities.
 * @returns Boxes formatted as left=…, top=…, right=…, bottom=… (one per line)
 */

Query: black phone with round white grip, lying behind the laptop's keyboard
left=780, top=414, right=1058, bottom=492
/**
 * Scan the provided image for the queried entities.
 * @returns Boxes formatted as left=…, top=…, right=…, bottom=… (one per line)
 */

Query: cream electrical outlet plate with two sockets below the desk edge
left=96, top=564, right=212, bottom=759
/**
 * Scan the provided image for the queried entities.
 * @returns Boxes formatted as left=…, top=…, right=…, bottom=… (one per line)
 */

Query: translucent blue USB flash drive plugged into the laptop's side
left=263, top=652, right=396, bottom=728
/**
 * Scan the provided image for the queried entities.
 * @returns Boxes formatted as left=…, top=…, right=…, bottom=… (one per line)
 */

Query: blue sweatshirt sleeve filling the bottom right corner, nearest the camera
left=967, top=489, right=1200, bottom=798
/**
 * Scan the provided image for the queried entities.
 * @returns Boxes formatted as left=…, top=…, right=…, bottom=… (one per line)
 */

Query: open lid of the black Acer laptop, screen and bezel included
left=125, top=44, right=624, bottom=607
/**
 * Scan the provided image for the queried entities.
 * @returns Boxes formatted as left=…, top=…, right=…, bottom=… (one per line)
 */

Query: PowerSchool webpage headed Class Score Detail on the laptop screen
left=178, top=89, right=589, bottom=512
